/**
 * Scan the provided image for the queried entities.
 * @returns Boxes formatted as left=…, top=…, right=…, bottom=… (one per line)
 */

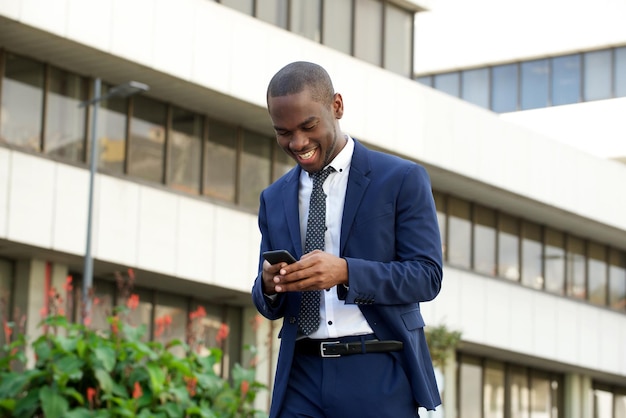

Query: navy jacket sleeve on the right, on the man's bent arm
left=342, top=164, right=443, bottom=305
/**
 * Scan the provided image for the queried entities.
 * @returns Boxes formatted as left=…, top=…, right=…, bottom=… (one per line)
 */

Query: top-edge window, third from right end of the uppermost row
left=322, top=0, right=352, bottom=54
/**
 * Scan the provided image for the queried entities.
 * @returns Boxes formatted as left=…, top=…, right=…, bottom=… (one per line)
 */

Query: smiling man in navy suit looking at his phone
left=252, top=62, right=442, bottom=418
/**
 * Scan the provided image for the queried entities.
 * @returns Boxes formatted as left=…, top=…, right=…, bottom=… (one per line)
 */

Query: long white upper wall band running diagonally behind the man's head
left=0, top=0, right=626, bottom=233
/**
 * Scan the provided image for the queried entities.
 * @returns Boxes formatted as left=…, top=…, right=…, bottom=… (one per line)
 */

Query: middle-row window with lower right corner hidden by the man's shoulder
left=239, top=131, right=275, bottom=210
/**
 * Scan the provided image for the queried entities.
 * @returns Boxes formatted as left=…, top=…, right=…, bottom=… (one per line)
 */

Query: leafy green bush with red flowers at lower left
left=0, top=315, right=266, bottom=418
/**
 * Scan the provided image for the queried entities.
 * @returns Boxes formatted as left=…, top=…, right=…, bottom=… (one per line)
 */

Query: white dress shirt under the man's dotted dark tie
left=298, top=135, right=373, bottom=338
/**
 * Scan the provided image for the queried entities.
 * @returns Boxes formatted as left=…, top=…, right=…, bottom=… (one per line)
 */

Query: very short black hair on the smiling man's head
left=266, top=61, right=335, bottom=105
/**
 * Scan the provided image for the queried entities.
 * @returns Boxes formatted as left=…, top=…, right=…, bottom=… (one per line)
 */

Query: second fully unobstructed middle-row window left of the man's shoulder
left=167, top=108, right=203, bottom=194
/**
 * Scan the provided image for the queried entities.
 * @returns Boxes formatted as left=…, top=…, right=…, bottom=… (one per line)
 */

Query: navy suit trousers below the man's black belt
left=279, top=337, right=418, bottom=418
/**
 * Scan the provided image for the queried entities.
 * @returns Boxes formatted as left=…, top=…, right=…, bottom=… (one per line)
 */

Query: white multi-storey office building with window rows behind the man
left=0, top=0, right=626, bottom=418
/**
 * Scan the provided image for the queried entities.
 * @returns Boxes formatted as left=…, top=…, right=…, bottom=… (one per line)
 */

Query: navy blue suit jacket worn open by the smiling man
left=252, top=141, right=442, bottom=417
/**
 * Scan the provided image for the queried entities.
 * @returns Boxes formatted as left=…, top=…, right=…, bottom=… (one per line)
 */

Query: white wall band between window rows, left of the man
left=0, top=148, right=260, bottom=293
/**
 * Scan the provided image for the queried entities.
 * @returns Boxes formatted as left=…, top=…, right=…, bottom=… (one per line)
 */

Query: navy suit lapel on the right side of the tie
left=339, top=140, right=371, bottom=255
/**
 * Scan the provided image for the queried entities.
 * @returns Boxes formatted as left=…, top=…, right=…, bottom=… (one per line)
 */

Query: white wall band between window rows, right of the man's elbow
left=422, top=267, right=626, bottom=376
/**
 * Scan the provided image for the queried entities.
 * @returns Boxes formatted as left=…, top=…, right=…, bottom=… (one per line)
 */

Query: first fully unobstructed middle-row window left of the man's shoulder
left=202, top=122, right=238, bottom=203
